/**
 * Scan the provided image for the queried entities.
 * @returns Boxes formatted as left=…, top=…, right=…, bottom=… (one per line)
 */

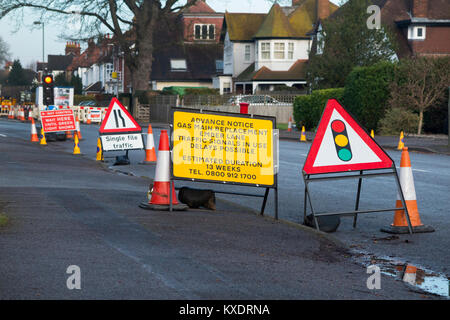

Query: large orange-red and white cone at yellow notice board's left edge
left=139, top=130, right=187, bottom=210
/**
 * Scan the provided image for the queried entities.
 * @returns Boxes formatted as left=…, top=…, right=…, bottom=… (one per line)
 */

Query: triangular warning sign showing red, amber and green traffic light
left=303, top=99, right=393, bottom=174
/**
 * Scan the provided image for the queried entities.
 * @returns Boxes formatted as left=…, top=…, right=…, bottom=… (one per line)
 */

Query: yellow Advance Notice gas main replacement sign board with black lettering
left=173, top=111, right=275, bottom=186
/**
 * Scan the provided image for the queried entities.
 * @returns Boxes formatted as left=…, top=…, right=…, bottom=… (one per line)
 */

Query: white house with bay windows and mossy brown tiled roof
left=214, top=0, right=338, bottom=94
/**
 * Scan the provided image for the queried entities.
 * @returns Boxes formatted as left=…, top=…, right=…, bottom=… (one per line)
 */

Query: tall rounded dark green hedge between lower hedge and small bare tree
left=343, top=62, right=396, bottom=131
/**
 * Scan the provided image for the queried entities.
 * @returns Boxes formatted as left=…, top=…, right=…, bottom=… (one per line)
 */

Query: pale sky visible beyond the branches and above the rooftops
left=0, top=0, right=341, bottom=67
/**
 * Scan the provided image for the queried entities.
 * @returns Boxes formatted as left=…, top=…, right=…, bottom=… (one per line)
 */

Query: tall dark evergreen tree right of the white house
left=307, top=0, right=395, bottom=89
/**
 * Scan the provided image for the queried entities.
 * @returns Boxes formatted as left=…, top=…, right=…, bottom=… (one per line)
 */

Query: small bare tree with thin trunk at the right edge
left=390, top=57, right=450, bottom=134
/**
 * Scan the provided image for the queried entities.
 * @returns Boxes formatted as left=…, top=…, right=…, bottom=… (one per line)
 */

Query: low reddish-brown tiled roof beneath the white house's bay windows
left=236, top=59, right=307, bottom=81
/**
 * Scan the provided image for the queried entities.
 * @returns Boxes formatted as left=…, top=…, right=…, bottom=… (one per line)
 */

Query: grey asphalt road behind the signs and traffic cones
left=0, top=117, right=450, bottom=292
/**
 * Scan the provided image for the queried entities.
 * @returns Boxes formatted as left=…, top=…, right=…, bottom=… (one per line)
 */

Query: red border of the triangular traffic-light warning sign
left=303, top=99, right=394, bottom=174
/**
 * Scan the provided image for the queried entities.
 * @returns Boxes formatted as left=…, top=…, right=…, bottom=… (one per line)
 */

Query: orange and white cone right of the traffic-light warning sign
left=381, top=147, right=434, bottom=233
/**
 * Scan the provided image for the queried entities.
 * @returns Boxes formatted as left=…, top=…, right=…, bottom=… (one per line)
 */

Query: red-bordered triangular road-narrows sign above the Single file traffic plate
left=99, top=98, right=142, bottom=134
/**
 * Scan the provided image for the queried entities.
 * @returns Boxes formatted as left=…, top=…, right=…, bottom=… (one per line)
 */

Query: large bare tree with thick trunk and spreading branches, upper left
left=0, top=0, right=200, bottom=91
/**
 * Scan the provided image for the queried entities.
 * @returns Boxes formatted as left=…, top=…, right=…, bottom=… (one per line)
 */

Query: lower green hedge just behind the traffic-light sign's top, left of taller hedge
left=294, top=88, right=344, bottom=130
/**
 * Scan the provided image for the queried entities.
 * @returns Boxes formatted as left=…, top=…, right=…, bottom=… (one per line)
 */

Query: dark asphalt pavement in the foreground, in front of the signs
left=0, top=120, right=442, bottom=300
